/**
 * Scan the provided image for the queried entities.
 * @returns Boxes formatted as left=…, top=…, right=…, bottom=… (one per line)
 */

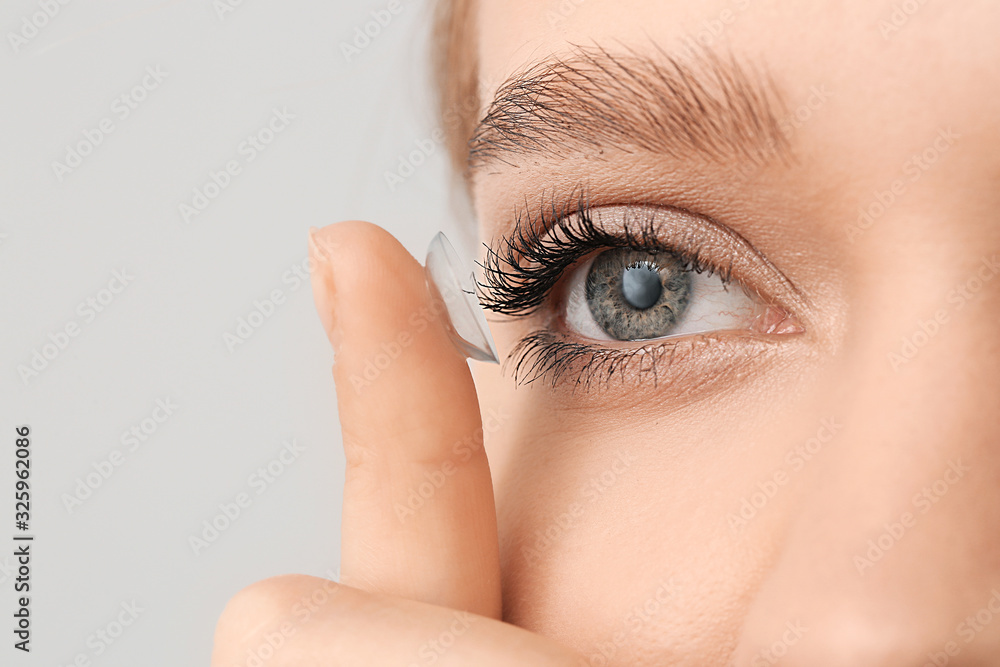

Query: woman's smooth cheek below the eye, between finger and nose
left=476, top=326, right=826, bottom=665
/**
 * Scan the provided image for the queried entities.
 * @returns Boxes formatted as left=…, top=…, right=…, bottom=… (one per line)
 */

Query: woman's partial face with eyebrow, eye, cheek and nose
left=471, top=0, right=1000, bottom=665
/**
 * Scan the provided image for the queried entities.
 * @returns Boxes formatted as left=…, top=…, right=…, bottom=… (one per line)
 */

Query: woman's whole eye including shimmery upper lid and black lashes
left=480, top=197, right=807, bottom=386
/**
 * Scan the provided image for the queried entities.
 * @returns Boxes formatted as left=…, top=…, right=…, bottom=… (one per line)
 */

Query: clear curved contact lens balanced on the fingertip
left=424, top=232, right=500, bottom=363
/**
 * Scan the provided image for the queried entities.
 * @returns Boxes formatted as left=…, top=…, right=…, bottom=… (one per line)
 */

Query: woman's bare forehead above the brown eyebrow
left=477, top=0, right=1000, bottom=136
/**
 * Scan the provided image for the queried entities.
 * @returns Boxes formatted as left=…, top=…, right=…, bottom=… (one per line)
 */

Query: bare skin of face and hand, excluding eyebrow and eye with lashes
left=212, top=0, right=1000, bottom=667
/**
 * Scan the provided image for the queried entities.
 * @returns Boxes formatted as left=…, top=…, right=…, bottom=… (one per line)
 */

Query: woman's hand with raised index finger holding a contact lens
left=212, top=222, right=581, bottom=667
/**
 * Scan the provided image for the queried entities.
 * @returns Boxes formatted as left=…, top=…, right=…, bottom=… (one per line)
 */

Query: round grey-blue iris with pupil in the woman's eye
left=586, top=248, right=691, bottom=340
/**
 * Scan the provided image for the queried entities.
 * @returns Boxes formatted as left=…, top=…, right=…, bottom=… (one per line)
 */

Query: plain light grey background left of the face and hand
left=0, top=0, right=460, bottom=666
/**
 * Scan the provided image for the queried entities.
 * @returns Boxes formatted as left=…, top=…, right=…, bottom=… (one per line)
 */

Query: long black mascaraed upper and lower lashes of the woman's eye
left=479, top=188, right=769, bottom=388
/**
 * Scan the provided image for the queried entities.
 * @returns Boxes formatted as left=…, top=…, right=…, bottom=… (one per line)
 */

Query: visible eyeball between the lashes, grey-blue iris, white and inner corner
left=560, top=248, right=803, bottom=341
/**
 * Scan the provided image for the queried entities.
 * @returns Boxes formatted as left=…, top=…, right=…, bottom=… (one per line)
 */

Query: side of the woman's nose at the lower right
left=736, top=254, right=1000, bottom=666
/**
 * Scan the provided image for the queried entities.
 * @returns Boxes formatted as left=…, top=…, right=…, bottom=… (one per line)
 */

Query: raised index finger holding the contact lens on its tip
left=310, top=222, right=500, bottom=618
